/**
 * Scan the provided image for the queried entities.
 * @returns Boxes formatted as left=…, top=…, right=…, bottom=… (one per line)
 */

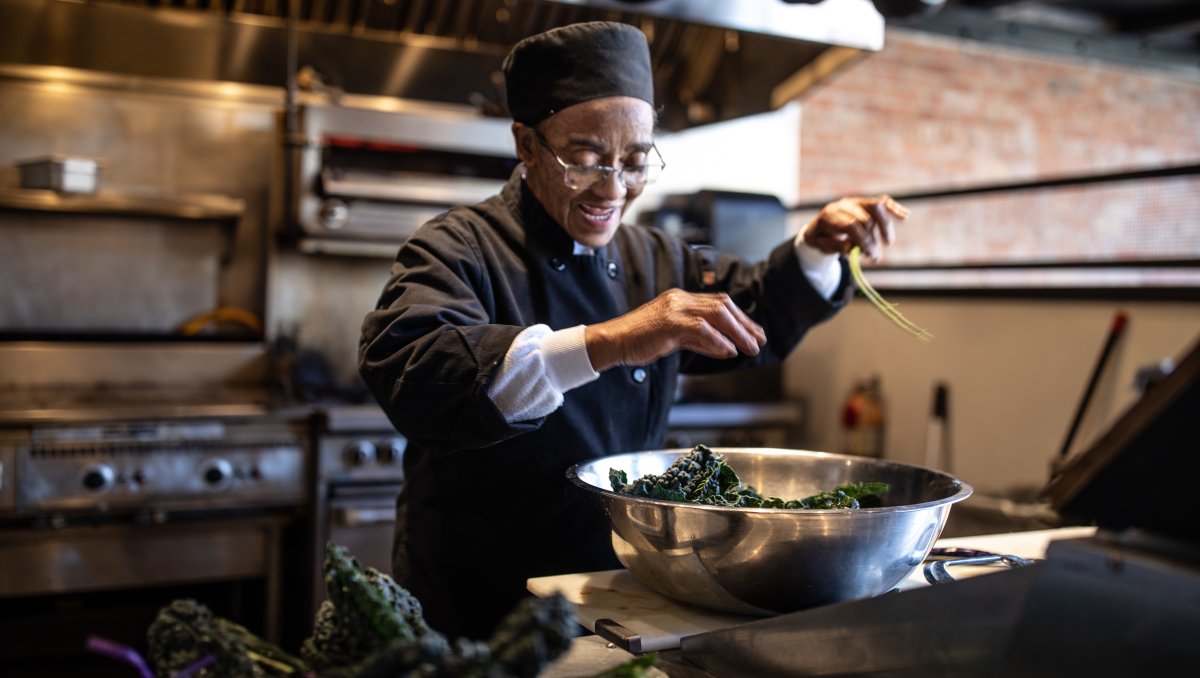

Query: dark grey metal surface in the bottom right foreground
left=682, top=534, right=1200, bottom=678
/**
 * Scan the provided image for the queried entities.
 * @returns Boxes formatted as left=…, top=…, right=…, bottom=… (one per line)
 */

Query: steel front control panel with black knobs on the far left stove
left=13, top=420, right=305, bottom=515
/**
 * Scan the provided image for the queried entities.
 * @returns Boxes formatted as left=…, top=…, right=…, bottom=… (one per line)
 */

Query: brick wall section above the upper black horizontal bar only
left=800, top=29, right=1200, bottom=200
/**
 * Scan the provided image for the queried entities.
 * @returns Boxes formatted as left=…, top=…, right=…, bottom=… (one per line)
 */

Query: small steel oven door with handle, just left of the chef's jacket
left=326, top=484, right=402, bottom=575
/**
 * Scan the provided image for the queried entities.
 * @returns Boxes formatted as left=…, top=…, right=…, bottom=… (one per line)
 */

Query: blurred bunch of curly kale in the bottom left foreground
left=146, top=544, right=578, bottom=678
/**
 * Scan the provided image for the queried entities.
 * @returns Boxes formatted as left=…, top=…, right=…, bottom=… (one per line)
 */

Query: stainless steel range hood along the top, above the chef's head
left=0, top=0, right=883, bottom=130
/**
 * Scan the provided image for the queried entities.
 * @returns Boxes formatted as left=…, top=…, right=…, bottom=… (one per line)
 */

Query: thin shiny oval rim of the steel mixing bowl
left=566, top=445, right=974, bottom=516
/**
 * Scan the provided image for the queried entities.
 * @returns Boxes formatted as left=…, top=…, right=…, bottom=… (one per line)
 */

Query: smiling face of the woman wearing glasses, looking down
left=512, top=97, right=654, bottom=248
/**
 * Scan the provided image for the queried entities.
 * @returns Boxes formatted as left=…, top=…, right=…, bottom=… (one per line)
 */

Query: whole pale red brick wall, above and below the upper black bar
left=799, top=30, right=1200, bottom=270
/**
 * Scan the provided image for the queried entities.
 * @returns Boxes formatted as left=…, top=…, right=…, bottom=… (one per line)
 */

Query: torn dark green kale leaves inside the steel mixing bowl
left=608, top=445, right=888, bottom=509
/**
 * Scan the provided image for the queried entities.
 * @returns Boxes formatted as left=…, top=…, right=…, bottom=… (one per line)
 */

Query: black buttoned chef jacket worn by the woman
left=360, top=166, right=847, bottom=638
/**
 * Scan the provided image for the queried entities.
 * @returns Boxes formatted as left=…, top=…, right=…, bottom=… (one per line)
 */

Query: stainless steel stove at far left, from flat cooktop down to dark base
left=0, top=342, right=312, bottom=677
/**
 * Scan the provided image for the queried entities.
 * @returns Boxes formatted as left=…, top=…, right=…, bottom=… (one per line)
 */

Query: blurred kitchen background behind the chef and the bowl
left=0, top=0, right=1200, bottom=674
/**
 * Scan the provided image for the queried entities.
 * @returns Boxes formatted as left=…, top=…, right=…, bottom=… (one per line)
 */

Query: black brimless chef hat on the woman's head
left=504, top=22, right=654, bottom=125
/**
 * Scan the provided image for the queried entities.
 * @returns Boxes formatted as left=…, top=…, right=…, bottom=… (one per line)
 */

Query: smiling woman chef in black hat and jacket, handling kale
left=359, top=22, right=906, bottom=638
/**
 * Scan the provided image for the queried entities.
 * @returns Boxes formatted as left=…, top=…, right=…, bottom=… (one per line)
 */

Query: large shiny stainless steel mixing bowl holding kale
left=566, top=448, right=972, bottom=614
